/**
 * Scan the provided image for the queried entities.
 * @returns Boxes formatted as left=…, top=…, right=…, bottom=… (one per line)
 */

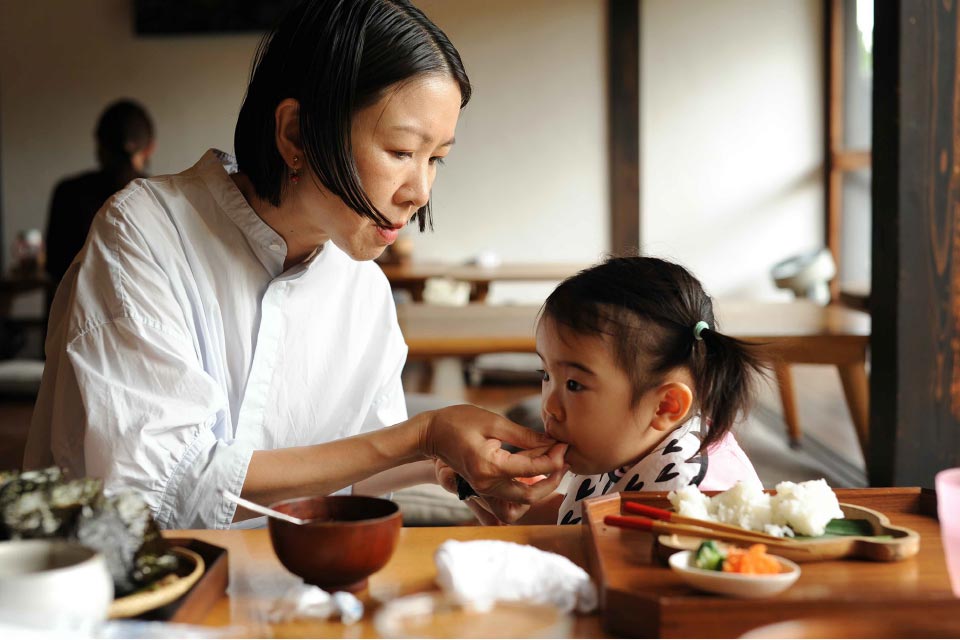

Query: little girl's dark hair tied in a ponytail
left=542, top=252, right=767, bottom=451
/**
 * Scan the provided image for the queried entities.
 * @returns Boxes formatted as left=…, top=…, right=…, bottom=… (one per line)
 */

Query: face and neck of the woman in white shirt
left=293, top=75, right=460, bottom=260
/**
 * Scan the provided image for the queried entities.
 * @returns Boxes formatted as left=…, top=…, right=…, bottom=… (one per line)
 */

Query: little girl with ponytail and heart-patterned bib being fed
left=445, top=257, right=764, bottom=524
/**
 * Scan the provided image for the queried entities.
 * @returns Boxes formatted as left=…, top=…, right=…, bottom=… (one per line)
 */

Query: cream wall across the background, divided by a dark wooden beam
left=0, top=0, right=822, bottom=301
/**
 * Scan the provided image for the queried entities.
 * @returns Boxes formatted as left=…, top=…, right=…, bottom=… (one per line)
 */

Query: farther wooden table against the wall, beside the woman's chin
left=380, top=262, right=588, bottom=302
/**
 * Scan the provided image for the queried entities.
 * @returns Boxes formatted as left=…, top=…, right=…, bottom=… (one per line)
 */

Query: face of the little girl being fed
left=537, top=316, right=664, bottom=475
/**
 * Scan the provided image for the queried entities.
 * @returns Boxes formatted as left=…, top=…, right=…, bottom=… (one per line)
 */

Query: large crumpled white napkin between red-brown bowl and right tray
left=434, top=540, right=597, bottom=613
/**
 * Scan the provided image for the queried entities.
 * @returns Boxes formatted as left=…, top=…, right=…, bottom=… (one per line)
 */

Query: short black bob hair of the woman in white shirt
left=234, top=0, right=471, bottom=231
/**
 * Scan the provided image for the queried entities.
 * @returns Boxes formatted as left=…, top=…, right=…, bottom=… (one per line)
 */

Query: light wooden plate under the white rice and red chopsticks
left=657, top=503, right=920, bottom=562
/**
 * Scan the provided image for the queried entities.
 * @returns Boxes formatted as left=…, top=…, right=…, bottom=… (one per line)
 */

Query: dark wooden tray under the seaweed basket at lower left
left=136, top=538, right=230, bottom=624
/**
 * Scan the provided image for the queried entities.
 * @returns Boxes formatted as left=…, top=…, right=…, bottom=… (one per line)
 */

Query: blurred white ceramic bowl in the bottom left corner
left=0, top=540, right=113, bottom=630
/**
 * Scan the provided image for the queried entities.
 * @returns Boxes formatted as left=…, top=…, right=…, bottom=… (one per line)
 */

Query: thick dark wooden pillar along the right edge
left=867, top=0, right=960, bottom=487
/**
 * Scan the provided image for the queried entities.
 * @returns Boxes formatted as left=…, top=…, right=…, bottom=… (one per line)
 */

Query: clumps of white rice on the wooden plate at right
left=667, top=478, right=843, bottom=537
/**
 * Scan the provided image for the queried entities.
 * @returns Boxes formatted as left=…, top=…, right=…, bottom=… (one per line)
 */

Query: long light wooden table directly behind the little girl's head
left=397, top=300, right=870, bottom=453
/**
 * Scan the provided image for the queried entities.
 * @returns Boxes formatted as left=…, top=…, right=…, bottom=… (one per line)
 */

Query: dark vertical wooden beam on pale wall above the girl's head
left=607, top=0, right=640, bottom=253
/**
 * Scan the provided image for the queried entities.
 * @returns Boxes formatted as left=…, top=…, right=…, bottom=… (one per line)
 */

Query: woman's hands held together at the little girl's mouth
left=420, top=405, right=567, bottom=522
